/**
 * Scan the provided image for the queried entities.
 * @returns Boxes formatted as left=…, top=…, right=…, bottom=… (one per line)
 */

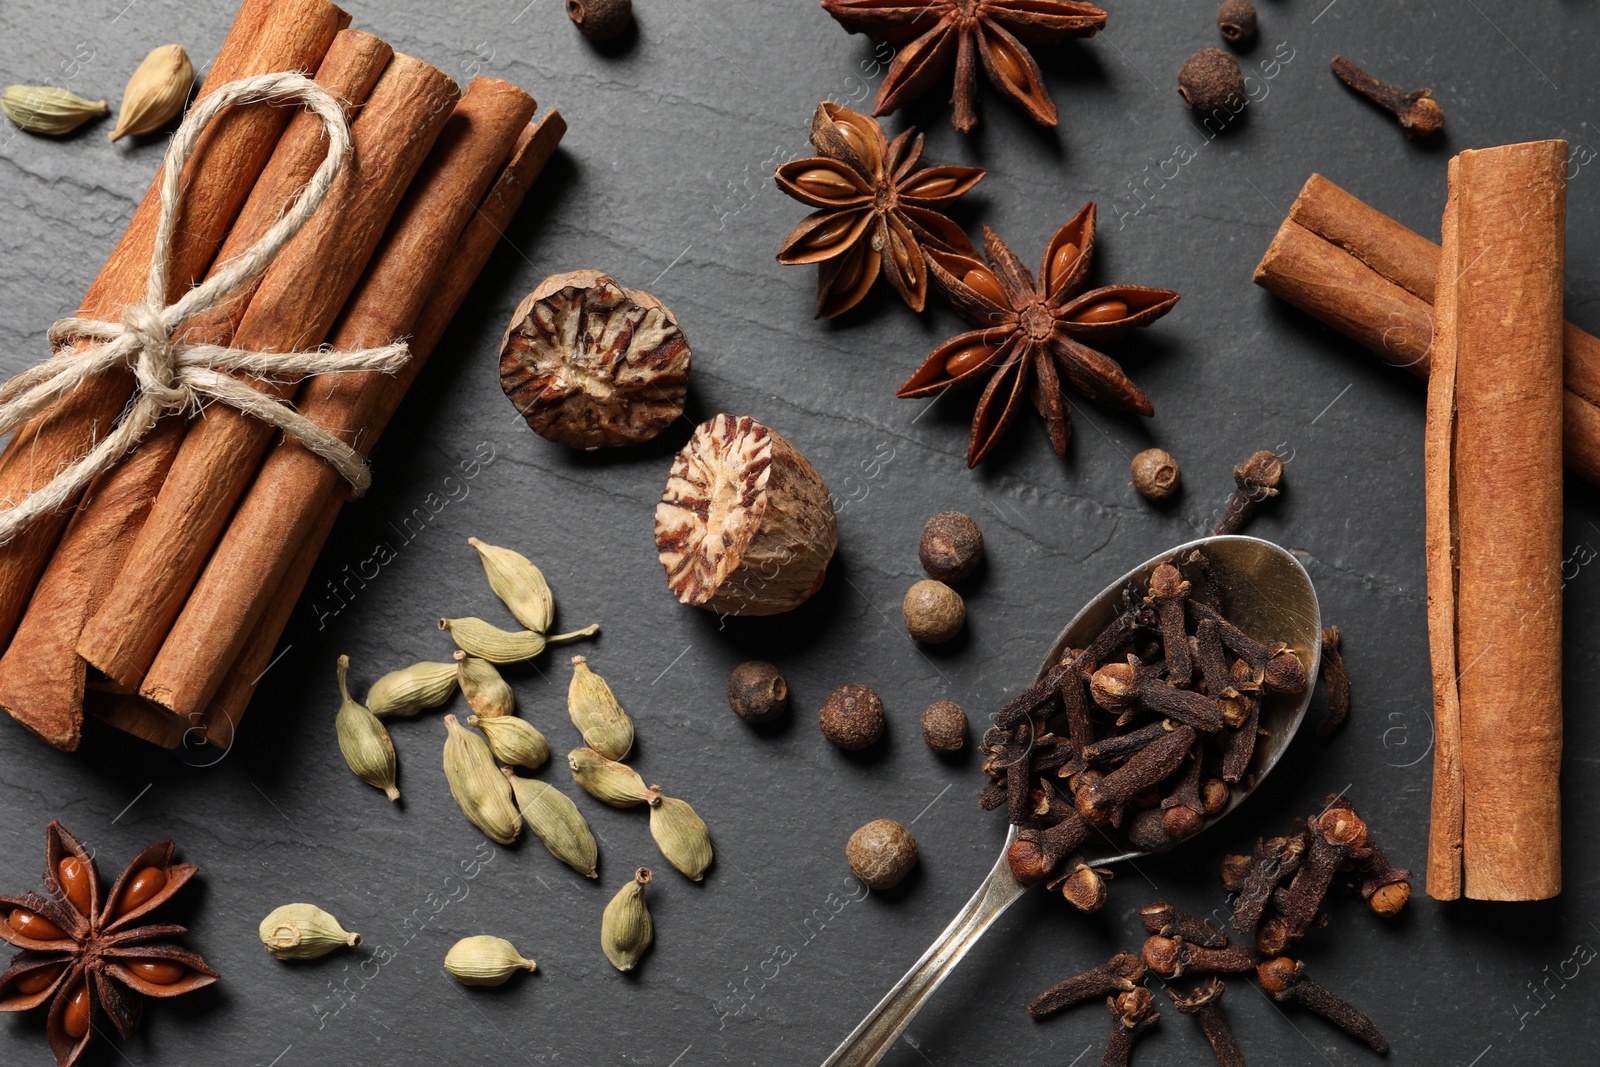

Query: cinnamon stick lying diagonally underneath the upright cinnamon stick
left=1256, top=174, right=1600, bottom=485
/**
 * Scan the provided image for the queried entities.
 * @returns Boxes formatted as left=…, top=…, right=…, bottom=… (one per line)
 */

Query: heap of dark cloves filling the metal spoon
left=979, top=550, right=1307, bottom=910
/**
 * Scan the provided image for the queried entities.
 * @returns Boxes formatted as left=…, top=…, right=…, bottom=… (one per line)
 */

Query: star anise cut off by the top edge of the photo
left=822, top=0, right=1106, bottom=133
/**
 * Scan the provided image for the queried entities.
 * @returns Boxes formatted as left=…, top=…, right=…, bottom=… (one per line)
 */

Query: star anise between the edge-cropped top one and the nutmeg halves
left=778, top=102, right=984, bottom=318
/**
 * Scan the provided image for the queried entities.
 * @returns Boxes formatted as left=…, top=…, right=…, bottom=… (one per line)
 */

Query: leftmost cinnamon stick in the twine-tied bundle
left=0, top=0, right=350, bottom=641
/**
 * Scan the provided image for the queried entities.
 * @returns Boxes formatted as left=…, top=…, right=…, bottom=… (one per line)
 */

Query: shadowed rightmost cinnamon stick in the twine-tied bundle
left=192, top=110, right=566, bottom=749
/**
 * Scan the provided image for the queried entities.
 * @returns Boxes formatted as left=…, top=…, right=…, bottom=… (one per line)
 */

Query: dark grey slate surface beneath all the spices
left=0, top=0, right=1600, bottom=1067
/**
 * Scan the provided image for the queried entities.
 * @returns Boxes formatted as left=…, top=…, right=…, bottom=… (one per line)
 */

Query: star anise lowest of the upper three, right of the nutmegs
left=894, top=202, right=1178, bottom=467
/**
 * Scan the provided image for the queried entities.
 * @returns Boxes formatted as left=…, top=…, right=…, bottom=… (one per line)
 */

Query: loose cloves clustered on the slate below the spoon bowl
left=1027, top=793, right=1411, bottom=1067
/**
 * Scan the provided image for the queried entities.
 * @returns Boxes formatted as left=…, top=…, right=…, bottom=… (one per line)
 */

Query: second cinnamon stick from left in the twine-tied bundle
left=0, top=30, right=394, bottom=750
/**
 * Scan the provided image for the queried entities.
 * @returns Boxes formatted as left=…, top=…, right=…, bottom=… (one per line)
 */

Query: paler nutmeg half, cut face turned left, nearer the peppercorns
left=656, top=414, right=838, bottom=614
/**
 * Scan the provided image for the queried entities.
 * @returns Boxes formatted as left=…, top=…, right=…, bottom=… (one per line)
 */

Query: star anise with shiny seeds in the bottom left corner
left=0, top=822, right=218, bottom=1067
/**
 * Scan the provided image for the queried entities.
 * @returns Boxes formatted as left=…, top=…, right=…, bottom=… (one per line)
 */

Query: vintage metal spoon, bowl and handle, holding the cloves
left=822, top=536, right=1322, bottom=1067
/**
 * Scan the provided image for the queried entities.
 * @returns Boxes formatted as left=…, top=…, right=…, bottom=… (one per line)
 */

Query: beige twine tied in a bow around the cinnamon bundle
left=0, top=74, right=411, bottom=544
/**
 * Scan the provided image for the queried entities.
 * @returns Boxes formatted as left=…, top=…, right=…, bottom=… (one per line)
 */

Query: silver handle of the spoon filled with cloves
left=822, top=827, right=1027, bottom=1067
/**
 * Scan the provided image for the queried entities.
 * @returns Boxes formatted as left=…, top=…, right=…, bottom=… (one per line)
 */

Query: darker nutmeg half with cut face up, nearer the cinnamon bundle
left=501, top=270, right=690, bottom=451
